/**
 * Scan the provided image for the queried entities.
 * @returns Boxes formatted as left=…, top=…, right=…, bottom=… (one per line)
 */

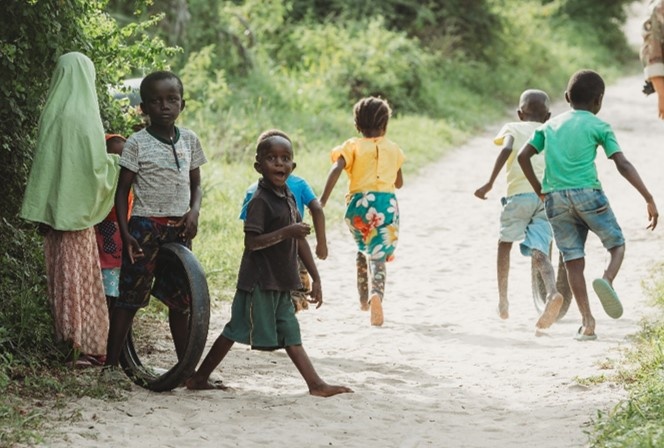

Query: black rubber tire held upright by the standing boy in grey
left=120, top=243, right=210, bottom=392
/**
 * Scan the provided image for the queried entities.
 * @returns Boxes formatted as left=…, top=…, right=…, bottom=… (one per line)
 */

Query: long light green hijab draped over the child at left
left=20, top=52, right=119, bottom=230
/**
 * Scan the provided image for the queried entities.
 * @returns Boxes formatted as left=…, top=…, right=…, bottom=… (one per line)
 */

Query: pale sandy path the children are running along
left=44, top=9, right=664, bottom=448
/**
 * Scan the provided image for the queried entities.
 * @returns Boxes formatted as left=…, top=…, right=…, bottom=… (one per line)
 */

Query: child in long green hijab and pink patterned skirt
left=20, top=52, right=119, bottom=365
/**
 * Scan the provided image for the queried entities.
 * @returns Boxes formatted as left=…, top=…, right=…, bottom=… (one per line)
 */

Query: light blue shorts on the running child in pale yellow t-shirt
left=498, top=193, right=553, bottom=256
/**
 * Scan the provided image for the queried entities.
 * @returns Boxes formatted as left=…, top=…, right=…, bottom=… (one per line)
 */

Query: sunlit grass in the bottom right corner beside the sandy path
left=591, top=265, right=664, bottom=448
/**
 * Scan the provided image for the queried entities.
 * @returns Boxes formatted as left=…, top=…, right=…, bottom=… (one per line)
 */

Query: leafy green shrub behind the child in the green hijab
left=0, top=0, right=175, bottom=370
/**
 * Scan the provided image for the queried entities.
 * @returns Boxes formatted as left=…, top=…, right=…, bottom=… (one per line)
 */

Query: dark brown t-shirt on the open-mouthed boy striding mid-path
left=237, top=179, right=302, bottom=291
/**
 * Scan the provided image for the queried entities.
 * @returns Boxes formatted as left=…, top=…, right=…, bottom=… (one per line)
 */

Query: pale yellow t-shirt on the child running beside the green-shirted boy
left=493, top=121, right=544, bottom=196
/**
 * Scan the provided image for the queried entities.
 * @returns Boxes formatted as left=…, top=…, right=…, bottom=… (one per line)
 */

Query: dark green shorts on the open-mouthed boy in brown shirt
left=221, top=287, right=302, bottom=350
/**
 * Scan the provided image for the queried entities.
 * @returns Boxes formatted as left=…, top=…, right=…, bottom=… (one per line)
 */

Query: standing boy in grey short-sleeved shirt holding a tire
left=102, top=71, right=207, bottom=377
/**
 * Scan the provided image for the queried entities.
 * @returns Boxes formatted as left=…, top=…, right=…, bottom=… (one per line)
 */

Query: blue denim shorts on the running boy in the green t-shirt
left=544, top=188, right=625, bottom=261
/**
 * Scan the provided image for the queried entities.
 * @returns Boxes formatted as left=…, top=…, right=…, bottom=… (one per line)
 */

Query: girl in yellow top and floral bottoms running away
left=320, top=97, right=404, bottom=326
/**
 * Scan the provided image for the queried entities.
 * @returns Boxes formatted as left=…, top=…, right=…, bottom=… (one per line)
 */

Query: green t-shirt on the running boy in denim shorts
left=529, top=110, right=620, bottom=193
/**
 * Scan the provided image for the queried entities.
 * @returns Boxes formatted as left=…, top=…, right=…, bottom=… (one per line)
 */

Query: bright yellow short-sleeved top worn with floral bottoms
left=331, top=136, right=405, bottom=197
